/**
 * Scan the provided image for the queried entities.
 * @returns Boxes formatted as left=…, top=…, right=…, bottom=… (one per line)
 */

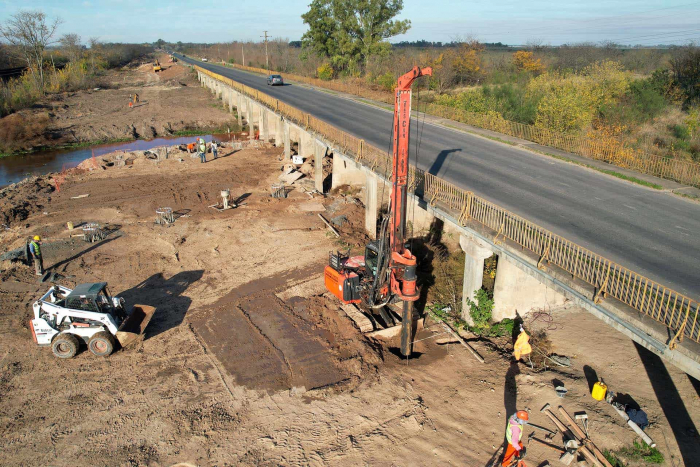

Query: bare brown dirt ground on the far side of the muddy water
left=0, top=55, right=236, bottom=150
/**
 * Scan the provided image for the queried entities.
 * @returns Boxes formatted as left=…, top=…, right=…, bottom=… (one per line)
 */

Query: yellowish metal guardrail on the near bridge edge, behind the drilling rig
left=195, top=66, right=700, bottom=348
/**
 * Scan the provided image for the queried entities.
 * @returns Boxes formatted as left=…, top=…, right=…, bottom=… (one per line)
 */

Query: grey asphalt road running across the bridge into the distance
left=178, top=56, right=700, bottom=299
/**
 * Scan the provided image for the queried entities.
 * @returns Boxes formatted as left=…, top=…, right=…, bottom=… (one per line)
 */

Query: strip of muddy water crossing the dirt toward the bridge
left=0, top=134, right=238, bottom=188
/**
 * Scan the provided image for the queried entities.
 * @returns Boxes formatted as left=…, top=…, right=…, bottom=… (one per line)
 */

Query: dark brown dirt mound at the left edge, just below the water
left=0, top=177, right=55, bottom=227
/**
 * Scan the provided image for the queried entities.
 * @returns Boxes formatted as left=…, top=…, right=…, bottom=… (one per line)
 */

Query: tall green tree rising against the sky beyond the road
left=301, top=0, right=411, bottom=72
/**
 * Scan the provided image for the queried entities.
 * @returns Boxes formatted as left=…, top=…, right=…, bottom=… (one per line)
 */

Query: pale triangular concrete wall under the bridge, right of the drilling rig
left=493, top=255, right=566, bottom=322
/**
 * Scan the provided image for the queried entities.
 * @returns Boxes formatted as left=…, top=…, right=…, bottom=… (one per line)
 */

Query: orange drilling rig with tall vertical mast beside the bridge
left=324, top=66, right=433, bottom=356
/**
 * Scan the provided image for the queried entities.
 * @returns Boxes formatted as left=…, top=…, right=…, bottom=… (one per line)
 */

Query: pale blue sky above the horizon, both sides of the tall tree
left=0, top=0, right=700, bottom=45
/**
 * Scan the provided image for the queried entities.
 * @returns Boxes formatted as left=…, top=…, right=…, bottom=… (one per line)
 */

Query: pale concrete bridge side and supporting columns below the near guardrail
left=187, top=58, right=700, bottom=379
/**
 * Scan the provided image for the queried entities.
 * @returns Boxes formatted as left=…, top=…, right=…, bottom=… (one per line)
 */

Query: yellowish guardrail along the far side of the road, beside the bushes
left=213, top=60, right=700, bottom=188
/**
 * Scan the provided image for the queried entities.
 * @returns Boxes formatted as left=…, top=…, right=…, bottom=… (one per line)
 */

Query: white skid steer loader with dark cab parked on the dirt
left=29, top=282, right=155, bottom=358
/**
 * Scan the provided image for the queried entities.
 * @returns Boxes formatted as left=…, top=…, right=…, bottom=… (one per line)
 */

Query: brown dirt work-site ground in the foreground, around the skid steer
left=0, top=144, right=700, bottom=466
